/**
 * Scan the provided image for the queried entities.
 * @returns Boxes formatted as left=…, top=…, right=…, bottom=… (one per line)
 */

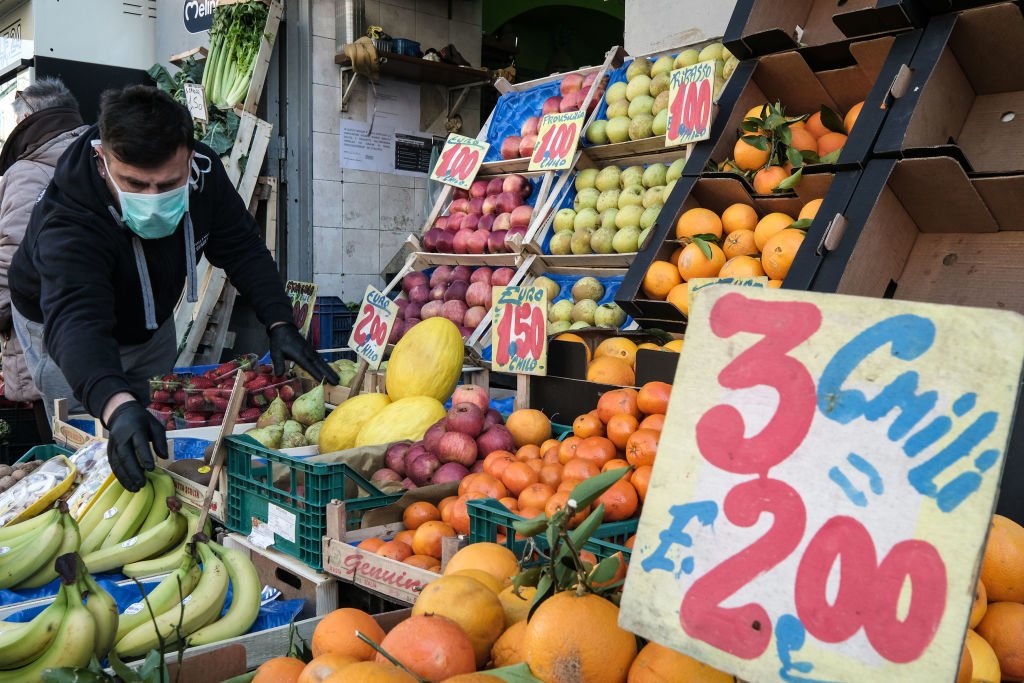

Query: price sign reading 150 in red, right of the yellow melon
left=490, top=287, right=548, bottom=375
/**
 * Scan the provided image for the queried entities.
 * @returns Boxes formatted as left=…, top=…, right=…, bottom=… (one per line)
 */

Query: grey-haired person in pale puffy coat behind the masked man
left=0, top=78, right=88, bottom=456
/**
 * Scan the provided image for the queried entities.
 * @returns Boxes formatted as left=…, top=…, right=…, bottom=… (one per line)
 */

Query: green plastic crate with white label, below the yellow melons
left=227, top=434, right=401, bottom=569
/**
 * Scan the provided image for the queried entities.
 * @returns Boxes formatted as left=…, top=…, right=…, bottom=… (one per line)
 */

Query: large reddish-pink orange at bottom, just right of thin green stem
left=377, top=618, right=475, bottom=681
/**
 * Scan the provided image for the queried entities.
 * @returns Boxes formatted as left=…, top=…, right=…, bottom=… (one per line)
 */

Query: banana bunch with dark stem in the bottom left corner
left=0, top=553, right=118, bottom=683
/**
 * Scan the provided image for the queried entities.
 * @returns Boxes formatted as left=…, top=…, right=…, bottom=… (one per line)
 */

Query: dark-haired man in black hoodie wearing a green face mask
left=10, top=86, right=338, bottom=490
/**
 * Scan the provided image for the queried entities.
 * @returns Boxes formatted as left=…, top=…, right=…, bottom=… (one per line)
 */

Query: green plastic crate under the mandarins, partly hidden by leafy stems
left=466, top=498, right=640, bottom=566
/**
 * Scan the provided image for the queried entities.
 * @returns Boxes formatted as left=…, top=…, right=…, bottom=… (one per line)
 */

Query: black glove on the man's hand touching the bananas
left=106, top=400, right=167, bottom=492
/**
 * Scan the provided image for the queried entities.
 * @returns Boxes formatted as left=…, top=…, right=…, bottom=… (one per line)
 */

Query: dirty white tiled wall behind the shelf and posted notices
left=312, top=0, right=482, bottom=301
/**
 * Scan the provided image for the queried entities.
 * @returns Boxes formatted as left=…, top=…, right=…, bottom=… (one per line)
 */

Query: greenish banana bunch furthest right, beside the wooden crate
left=113, top=535, right=260, bottom=655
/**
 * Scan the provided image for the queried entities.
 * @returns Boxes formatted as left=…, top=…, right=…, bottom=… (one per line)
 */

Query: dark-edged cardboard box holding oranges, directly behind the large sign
left=615, top=171, right=859, bottom=332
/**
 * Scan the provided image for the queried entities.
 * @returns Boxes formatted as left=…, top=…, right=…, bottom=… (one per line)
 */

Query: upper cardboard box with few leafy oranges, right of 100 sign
left=683, top=29, right=923, bottom=176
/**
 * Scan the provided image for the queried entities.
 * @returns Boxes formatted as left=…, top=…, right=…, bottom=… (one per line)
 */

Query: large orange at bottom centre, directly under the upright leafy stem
left=522, top=591, right=637, bottom=683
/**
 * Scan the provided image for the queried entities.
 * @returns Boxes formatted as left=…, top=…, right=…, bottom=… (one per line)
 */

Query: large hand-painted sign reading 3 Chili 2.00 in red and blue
left=620, top=286, right=1024, bottom=683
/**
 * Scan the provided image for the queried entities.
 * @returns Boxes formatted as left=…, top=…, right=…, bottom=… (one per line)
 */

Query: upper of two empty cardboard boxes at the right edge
left=876, top=3, right=1024, bottom=174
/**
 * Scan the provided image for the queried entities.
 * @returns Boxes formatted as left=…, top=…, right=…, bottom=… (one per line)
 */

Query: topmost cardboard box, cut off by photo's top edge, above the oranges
left=723, top=0, right=933, bottom=59
